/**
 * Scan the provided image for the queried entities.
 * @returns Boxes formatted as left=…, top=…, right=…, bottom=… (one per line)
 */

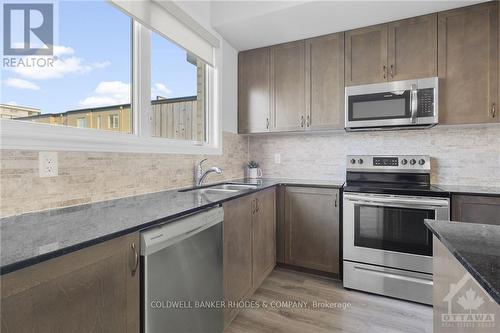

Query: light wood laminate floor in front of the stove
left=224, top=268, right=432, bottom=333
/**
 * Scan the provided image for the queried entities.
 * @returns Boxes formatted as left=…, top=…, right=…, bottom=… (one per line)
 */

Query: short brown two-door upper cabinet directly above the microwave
left=345, top=14, right=437, bottom=86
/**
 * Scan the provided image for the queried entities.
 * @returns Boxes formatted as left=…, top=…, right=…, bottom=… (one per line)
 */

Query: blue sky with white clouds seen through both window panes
left=0, top=1, right=196, bottom=113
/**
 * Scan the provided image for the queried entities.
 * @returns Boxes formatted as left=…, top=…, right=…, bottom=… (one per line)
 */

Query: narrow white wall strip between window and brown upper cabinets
left=175, top=0, right=238, bottom=133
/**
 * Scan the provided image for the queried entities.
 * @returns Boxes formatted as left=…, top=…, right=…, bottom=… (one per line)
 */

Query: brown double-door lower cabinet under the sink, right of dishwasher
left=222, top=188, right=276, bottom=325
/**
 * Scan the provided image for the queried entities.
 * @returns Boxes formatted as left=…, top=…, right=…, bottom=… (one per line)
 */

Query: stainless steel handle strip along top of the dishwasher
left=141, top=207, right=224, bottom=256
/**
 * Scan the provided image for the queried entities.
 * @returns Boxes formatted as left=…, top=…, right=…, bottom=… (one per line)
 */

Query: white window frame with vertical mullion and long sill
left=0, top=9, right=222, bottom=155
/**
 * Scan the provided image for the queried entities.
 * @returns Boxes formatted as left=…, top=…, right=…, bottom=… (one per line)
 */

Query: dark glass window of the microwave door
left=349, top=90, right=411, bottom=121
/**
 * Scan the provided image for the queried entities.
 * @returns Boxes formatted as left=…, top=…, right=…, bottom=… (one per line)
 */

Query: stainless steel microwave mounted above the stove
left=345, top=77, right=438, bottom=131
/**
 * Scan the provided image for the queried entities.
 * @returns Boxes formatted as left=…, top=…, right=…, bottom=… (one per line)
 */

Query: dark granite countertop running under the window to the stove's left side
left=0, top=179, right=343, bottom=274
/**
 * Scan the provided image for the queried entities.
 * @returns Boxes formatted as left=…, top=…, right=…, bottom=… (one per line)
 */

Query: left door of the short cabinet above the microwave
left=345, top=24, right=387, bottom=86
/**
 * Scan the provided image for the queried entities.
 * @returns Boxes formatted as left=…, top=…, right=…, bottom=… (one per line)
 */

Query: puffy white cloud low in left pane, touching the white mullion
left=78, top=81, right=130, bottom=108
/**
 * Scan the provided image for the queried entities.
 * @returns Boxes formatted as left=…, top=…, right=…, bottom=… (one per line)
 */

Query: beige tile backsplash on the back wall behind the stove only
left=250, top=124, right=500, bottom=186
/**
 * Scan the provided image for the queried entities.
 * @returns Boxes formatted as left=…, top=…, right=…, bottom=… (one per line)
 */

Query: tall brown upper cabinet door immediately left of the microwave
left=306, top=33, right=344, bottom=130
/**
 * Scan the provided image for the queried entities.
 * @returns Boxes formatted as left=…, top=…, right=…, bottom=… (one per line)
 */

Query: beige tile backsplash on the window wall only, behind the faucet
left=0, top=133, right=248, bottom=216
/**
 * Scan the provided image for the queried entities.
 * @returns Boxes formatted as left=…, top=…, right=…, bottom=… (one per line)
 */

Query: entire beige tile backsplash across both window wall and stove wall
left=0, top=125, right=500, bottom=216
